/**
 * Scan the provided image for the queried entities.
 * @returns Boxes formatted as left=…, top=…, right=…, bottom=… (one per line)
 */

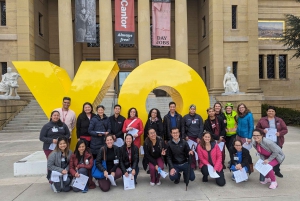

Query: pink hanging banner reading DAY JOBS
left=152, top=0, right=171, bottom=46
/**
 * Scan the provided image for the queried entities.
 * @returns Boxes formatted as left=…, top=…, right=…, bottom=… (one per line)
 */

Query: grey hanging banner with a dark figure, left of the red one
left=75, top=0, right=97, bottom=43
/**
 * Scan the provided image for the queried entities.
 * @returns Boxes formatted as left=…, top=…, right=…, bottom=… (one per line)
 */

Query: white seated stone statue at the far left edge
left=0, top=67, right=20, bottom=99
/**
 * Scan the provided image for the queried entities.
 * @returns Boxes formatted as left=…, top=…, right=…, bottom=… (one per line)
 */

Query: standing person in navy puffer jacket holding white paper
left=88, top=105, right=111, bottom=158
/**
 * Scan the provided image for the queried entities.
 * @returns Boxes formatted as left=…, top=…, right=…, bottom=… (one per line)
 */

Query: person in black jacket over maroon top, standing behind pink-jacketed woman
left=204, top=108, right=226, bottom=169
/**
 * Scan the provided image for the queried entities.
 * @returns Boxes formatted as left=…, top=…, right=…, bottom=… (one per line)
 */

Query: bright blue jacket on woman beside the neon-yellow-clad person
left=236, top=112, right=254, bottom=139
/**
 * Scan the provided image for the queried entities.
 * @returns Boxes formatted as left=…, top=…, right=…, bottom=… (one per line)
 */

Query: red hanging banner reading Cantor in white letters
left=115, top=0, right=135, bottom=44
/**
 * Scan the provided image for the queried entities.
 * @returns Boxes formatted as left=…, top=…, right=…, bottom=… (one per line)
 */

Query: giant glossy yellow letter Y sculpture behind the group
left=13, top=61, right=119, bottom=149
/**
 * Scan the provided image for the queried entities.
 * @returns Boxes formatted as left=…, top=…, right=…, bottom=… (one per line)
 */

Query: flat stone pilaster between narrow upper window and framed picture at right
left=247, top=0, right=262, bottom=93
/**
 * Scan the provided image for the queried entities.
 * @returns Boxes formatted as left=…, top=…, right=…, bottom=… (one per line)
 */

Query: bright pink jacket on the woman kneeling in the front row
left=197, top=142, right=223, bottom=172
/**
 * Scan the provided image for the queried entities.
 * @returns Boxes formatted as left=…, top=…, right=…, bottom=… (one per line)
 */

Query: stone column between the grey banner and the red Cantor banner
left=99, top=0, right=115, bottom=97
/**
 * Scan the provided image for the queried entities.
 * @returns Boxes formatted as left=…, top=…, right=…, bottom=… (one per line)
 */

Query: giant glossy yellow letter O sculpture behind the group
left=118, top=59, right=209, bottom=139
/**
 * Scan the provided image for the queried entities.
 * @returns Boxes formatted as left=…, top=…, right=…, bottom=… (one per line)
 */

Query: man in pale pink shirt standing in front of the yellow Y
left=55, top=97, right=76, bottom=139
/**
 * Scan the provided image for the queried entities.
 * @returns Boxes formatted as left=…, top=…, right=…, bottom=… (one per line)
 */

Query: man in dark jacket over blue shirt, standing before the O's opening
left=163, top=102, right=184, bottom=143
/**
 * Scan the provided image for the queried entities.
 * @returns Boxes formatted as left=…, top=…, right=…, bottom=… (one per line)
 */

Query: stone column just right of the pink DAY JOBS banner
left=175, top=0, right=188, bottom=64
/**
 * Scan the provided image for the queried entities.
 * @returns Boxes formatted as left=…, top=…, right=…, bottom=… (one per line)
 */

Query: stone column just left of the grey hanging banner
left=58, top=0, right=74, bottom=80
